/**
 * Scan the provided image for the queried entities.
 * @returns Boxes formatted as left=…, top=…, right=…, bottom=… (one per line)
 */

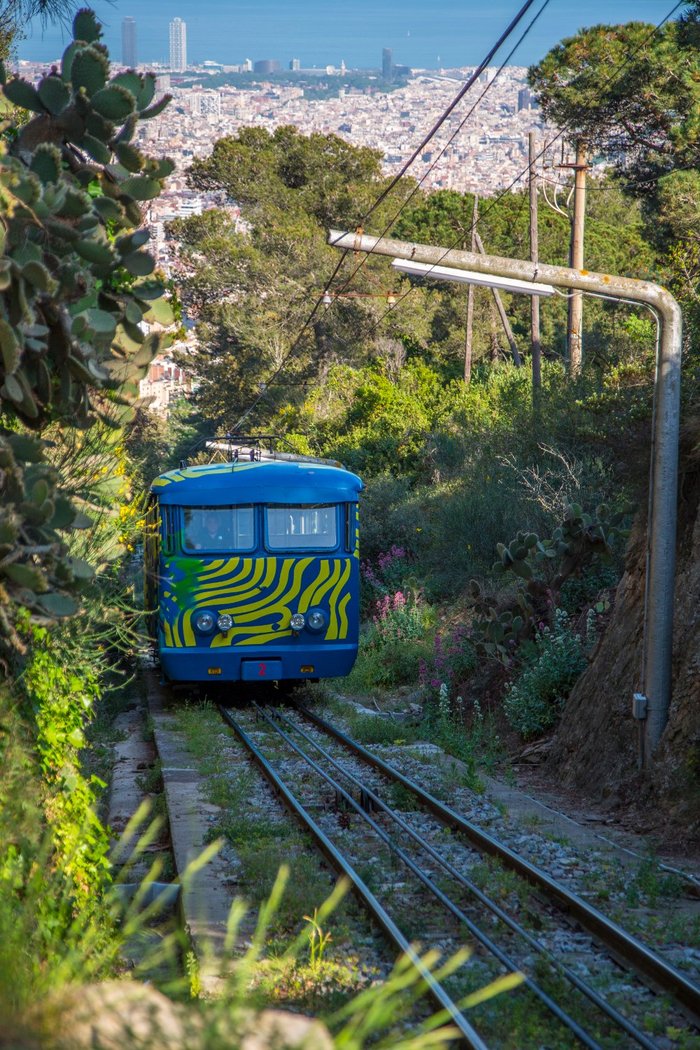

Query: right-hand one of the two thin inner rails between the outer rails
left=275, top=711, right=657, bottom=1050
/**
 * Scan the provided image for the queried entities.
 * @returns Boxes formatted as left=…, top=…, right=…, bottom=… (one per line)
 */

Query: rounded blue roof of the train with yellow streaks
left=151, top=458, right=363, bottom=506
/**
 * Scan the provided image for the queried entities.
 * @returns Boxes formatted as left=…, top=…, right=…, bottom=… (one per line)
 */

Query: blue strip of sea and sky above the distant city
left=18, top=0, right=682, bottom=69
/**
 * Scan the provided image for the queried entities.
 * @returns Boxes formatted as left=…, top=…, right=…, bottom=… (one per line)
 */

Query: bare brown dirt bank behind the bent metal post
left=547, top=425, right=700, bottom=843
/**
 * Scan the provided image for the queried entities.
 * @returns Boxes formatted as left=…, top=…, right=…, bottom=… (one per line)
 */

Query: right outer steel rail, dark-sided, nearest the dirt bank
left=295, top=704, right=700, bottom=1021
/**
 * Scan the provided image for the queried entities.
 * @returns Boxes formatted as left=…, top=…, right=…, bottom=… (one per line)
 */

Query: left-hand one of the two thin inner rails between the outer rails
left=255, top=705, right=601, bottom=1050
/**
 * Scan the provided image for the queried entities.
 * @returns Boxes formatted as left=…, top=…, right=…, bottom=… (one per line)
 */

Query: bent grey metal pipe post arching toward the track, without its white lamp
left=328, top=230, right=682, bottom=764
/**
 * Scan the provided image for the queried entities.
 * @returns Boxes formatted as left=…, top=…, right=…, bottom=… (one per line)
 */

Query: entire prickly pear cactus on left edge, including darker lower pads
left=0, top=9, right=173, bottom=663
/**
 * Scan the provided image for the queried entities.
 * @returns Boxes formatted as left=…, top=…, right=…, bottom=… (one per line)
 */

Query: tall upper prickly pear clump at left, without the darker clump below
left=0, top=9, right=173, bottom=427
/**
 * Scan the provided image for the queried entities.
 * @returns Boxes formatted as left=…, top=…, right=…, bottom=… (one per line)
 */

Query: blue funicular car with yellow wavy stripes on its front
left=145, top=437, right=362, bottom=684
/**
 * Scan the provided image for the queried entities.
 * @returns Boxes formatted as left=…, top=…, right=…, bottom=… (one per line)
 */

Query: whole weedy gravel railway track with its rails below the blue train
left=219, top=705, right=700, bottom=1050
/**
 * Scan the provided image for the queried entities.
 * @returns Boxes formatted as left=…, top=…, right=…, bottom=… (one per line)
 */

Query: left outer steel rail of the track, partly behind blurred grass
left=219, top=706, right=488, bottom=1050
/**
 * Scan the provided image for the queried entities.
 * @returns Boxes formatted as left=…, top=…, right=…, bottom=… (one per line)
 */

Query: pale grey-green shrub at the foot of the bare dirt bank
left=504, top=609, right=595, bottom=739
